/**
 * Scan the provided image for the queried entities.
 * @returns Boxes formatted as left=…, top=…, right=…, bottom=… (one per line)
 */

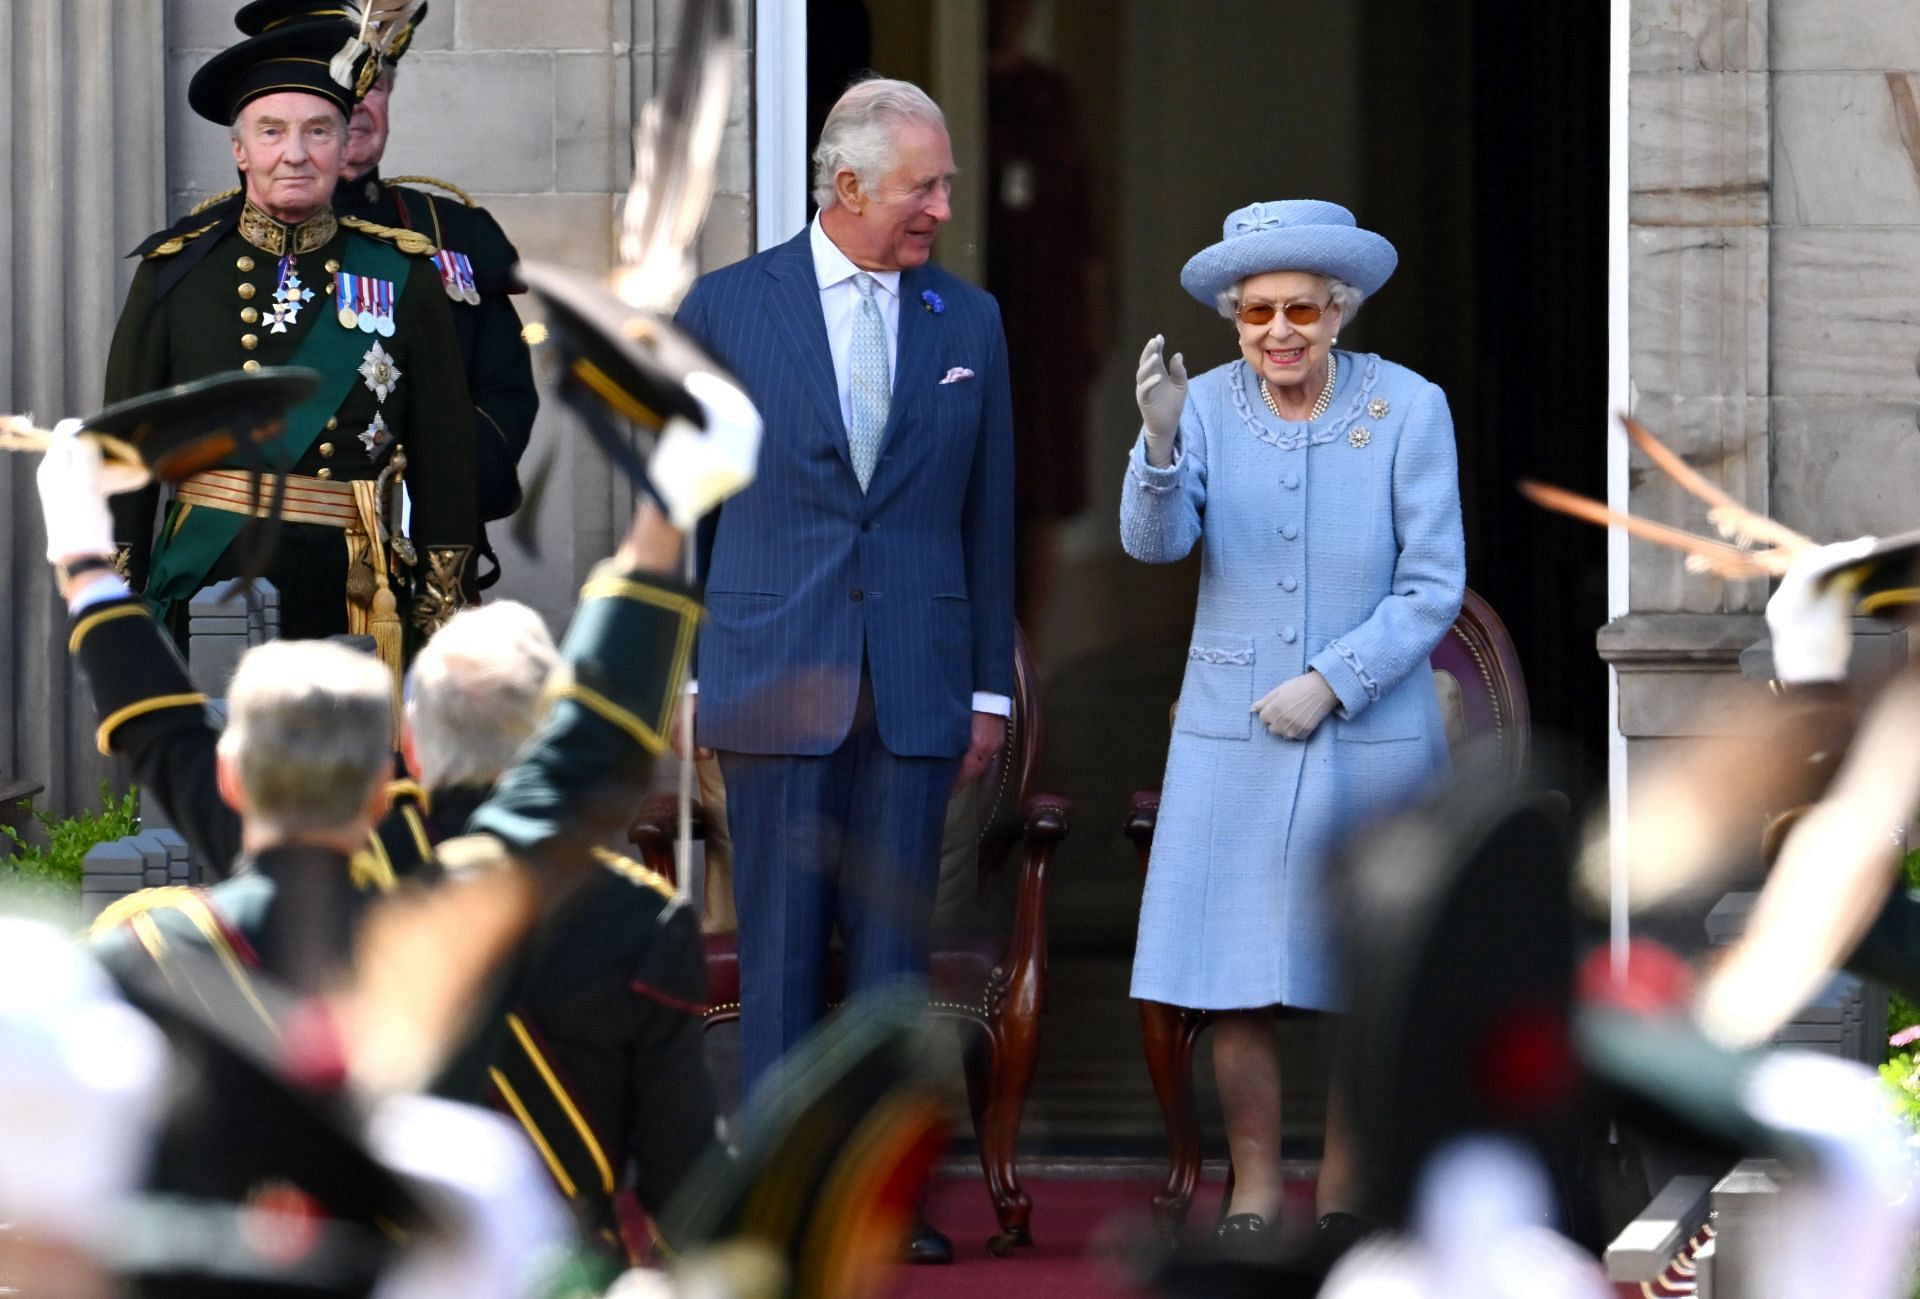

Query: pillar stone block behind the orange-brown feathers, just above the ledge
left=1628, top=395, right=1768, bottom=612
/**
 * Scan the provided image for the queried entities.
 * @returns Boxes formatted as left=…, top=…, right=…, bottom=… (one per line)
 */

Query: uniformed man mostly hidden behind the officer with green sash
left=228, top=0, right=540, bottom=589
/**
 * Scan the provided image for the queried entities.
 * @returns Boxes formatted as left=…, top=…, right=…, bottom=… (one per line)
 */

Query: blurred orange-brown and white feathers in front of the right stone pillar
left=1521, top=416, right=1814, bottom=579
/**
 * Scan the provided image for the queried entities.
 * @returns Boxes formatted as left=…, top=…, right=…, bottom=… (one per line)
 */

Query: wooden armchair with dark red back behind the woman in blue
left=1125, top=591, right=1528, bottom=1230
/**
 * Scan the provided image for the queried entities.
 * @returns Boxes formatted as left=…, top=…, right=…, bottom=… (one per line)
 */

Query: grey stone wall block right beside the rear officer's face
left=380, top=52, right=555, bottom=194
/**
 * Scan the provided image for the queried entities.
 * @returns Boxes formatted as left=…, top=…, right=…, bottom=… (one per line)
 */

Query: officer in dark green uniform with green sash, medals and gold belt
left=108, top=25, right=478, bottom=644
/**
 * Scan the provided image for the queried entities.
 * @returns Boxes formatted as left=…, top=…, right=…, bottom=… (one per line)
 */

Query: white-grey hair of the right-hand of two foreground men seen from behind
left=407, top=601, right=561, bottom=791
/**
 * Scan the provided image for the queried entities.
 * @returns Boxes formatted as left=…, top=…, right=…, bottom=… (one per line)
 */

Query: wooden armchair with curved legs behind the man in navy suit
left=628, top=631, right=1068, bottom=1257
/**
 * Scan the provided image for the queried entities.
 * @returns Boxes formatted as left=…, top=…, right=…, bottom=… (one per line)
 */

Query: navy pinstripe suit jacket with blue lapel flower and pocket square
left=678, top=230, right=1014, bottom=758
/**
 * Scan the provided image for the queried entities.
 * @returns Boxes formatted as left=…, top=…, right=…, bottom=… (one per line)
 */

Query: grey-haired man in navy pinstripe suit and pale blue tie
left=680, top=79, right=1014, bottom=1128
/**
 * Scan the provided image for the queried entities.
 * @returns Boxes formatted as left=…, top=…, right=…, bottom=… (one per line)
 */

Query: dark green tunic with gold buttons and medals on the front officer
left=106, top=205, right=478, bottom=637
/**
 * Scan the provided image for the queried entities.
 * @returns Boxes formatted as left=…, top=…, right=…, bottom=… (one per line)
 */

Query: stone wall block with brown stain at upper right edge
left=1774, top=71, right=1920, bottom=226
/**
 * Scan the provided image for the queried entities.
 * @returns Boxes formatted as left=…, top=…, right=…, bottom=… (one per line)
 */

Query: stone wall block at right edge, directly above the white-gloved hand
left=1772, top=391, right=1920, bottom=541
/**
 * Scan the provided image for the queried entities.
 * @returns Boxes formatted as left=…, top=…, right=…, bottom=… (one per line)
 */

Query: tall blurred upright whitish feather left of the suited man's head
left=612, top=0, right=733, bottom=313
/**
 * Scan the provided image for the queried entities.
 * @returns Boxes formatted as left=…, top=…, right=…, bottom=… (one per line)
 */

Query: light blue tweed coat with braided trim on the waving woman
left=1119, top=351, right=1467, bottom=1009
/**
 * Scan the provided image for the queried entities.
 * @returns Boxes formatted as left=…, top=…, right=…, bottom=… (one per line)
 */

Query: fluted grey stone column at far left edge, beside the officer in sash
left=0, top=0, right=165, bottom=808
